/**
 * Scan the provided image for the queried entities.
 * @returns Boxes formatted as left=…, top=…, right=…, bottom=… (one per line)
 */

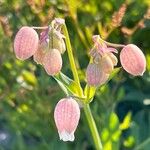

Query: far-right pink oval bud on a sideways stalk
left=120, top=44, right=146, bottom=76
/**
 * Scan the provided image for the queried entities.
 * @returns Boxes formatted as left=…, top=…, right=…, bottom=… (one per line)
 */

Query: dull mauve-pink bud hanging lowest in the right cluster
left=86, top=63, right=109, bottom=86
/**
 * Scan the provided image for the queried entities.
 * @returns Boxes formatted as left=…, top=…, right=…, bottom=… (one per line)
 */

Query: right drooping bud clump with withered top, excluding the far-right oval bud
left=86, top=35, right=118, bottom=86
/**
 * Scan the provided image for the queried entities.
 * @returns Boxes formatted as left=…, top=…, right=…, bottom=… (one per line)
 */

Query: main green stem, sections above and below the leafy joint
left=63, top=25, right=102, bottom=150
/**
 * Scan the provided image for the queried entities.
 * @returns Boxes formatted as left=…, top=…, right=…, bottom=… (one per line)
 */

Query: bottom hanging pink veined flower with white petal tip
left=54, top=97, right=80, bottom=141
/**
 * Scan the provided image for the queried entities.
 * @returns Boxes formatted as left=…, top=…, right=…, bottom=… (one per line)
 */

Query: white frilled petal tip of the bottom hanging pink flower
left=59, top=131, right=75, bottom=142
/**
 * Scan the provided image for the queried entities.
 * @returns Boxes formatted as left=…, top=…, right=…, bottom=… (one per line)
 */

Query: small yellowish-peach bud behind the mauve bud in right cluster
left=100, top=53, right=114, bottom=74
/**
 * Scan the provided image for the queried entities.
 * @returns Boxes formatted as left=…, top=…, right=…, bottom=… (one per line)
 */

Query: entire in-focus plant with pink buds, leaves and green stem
left=14, top=18, right=146, bottom=150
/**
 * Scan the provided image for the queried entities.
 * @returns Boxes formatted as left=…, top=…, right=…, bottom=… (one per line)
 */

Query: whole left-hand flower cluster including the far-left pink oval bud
left=14, top=18, right=66, bottom=76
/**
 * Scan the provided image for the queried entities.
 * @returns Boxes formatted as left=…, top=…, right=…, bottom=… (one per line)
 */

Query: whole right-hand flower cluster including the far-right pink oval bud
left=86, top=35, right=146, bottom=86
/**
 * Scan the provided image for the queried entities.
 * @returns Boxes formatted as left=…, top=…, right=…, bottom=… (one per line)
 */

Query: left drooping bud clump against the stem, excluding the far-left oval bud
left=33, top=18, right=66, bottom=76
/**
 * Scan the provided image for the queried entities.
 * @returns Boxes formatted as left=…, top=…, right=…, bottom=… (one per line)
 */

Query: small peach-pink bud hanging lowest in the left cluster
left=43, top=49, right=62, bottom=75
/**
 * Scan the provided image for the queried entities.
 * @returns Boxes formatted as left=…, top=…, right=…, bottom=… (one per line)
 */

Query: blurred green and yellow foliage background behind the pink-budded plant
left=0, top=0, right=150, bottom=150
